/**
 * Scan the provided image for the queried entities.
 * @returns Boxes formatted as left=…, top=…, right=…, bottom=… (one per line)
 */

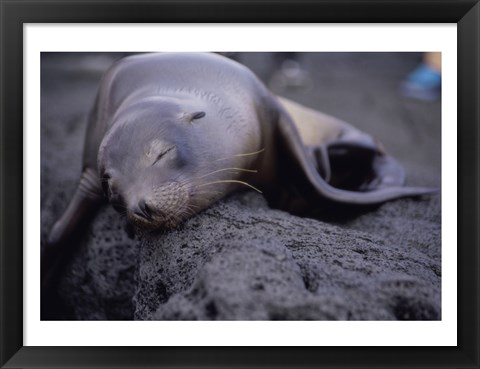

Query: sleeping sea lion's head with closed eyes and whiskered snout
left=98, top=99, right=223, bottom=229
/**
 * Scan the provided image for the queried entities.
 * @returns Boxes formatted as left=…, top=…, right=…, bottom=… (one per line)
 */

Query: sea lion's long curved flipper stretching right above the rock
left=274, top=96, right=436, bottom=205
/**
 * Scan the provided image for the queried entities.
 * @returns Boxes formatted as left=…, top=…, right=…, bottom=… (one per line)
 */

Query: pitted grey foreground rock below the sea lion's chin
left=135, top=193, right=440, bottom=320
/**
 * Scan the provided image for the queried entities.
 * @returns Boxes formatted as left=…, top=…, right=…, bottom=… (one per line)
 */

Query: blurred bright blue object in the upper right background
left=400, top=64, right=442, bottom=101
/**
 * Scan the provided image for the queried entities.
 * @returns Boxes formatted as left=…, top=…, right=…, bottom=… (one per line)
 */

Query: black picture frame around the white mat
left=0, top=0, right=480, bottom=368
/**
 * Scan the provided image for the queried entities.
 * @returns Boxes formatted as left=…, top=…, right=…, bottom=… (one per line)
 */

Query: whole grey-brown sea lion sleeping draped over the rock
left=42, top=53, right=431, bottom=278
